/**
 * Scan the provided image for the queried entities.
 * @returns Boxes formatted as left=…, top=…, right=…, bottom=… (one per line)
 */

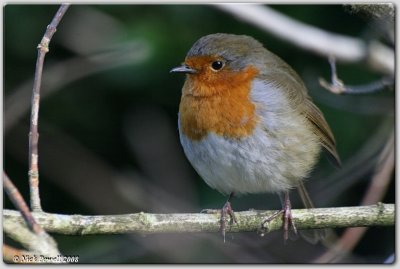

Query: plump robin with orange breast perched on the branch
left=171, top=33, right=340, bottom=241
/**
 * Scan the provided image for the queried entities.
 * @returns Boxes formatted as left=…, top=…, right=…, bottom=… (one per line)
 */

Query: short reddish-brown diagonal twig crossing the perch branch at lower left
left=3, top=172, right=44, bottom=234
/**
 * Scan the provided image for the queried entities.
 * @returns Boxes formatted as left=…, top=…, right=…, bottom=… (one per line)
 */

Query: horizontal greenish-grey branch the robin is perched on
left=3, top=203, right=395, bottom=235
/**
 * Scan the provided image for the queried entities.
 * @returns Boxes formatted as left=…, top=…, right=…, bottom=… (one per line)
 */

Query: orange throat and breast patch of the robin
left=179, top=66, right=258, bottom=140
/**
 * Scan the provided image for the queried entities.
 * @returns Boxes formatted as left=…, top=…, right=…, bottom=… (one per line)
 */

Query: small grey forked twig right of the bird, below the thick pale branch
left=319, top=56, right=394, bottom=94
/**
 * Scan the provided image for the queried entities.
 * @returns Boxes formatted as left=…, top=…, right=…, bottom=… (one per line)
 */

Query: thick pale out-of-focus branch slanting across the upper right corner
left=214, top=4, right=395, bottom=75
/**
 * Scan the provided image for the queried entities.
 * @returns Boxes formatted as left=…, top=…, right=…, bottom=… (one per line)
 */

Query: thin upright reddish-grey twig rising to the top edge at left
left=29, top=4, right=69, bottom=211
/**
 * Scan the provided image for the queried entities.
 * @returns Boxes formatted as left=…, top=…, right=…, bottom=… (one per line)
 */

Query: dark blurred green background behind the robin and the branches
left=3, top=5, right=395, bottom=263
